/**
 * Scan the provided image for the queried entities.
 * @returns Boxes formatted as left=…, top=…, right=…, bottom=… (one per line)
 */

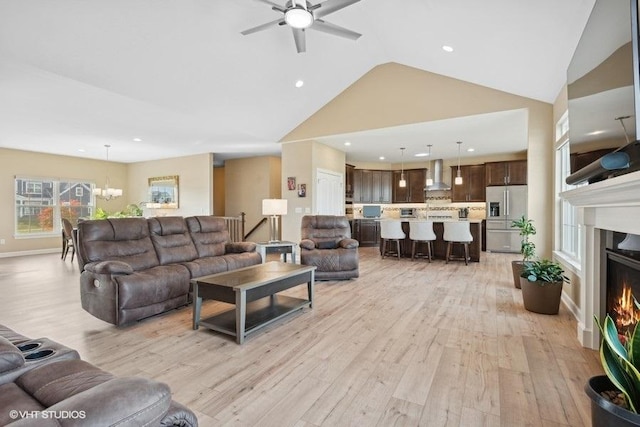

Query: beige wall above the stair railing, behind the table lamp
left=224, top=156, right=282, bottom=242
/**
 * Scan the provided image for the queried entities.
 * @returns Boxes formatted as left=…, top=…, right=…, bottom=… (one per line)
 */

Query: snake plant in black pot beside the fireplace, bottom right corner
left=584, top=315, right=640, bottom=427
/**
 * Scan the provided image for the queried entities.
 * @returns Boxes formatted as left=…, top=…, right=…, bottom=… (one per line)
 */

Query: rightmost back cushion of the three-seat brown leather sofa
left=186, top=216, right=229, bottom=258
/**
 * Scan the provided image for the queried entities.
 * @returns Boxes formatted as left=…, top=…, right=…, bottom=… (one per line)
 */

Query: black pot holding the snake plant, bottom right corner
left=584, top=375, right=640, bottom=427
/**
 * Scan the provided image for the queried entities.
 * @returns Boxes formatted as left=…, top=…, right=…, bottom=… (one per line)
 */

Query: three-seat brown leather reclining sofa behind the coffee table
left=77, top=216, right=262, bottom=325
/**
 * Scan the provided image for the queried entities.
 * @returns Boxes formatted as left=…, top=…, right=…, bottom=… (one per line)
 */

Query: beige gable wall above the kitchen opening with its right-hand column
left=283, top=63, right=554, bottom=256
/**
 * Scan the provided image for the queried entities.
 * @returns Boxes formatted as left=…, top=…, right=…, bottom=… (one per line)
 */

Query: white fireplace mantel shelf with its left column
left=560, top=171, right=640, bottom=349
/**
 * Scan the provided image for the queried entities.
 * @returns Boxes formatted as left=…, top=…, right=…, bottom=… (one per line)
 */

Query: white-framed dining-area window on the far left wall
left=15, top=177, right=94, bottom=237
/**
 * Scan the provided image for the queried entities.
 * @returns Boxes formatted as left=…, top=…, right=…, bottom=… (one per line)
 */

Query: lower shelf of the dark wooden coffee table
left=200, top=295, right=311, bottom=337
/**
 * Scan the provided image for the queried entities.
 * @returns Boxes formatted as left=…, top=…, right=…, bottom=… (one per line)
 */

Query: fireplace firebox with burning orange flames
left=605, top=231, right=640, bottom=339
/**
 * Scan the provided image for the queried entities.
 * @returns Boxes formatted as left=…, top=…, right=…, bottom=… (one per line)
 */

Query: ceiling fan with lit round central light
left=241, top=0, right=362, bottom=53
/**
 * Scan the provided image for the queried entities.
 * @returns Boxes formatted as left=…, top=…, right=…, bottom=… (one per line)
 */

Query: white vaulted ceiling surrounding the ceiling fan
left=0, top=0, right=594, bottom=162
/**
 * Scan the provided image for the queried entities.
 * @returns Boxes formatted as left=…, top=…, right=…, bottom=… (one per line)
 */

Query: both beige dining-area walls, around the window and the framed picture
left=0, top=148, right=213, bottom=256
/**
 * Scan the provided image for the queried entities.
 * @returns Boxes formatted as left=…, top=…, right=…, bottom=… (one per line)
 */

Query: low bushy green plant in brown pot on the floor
left=520, top=259, right=569, bottom=314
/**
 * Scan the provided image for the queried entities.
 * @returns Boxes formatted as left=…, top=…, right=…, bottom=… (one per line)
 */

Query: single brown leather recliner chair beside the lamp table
left=300, top=215, right=360, bottom=280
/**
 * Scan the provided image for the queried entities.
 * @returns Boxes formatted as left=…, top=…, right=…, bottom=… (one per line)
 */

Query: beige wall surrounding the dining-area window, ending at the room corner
left=0, top=148, right=127, bottom=255
